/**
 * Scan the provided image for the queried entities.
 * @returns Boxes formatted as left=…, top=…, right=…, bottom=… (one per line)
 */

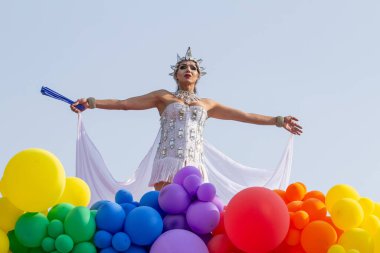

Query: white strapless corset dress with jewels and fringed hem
left=149, top=102, right=207, bottom=185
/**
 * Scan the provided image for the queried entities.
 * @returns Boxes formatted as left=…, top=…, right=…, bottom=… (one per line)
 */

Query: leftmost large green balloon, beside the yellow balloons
left=15, top=213, right=49, bottom=248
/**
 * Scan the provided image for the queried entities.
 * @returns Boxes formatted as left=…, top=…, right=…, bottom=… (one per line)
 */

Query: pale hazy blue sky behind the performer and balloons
left=0, top=0, right=380, bottom=201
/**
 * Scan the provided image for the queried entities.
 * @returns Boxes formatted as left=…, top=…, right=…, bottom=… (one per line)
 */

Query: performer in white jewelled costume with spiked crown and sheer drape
left=71, top=47, right=302, bottom=206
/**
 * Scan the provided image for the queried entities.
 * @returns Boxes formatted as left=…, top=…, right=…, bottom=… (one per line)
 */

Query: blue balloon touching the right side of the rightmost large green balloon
left=95, top=202, right=125, bottom=233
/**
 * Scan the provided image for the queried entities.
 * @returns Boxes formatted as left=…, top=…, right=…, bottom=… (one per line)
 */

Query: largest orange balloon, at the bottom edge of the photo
left=301, top=221, right=338, bottom=253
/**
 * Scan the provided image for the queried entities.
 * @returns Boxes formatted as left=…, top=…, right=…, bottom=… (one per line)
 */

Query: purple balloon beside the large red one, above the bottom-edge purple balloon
left=186, top=201, right=220, bottom=235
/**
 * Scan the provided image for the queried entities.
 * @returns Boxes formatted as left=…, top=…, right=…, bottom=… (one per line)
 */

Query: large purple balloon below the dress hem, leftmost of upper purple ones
left=158, top=184, right=190, bottom=214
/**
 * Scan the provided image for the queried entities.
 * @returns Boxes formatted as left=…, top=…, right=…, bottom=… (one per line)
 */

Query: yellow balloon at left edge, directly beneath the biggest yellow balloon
left=0, top=198, right=24, bottom=232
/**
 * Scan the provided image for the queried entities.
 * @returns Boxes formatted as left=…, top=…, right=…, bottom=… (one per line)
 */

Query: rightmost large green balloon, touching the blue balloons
left=63, top=206, right=96, bottom=243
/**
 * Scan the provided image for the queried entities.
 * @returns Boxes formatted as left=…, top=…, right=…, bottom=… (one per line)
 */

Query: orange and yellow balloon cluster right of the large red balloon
left=274, top=182, right=380, bottom=253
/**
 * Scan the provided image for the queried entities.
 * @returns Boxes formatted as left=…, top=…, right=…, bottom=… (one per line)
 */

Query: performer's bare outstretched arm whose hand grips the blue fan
left=70, top=90, right=163, bottom=113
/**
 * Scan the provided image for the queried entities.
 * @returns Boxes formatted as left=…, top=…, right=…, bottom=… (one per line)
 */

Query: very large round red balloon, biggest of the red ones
left=224, top=187, right=290, bottom=253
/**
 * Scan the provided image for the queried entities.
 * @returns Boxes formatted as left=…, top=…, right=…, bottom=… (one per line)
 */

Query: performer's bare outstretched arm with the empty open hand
left=206, top=99, right=302, bottom=135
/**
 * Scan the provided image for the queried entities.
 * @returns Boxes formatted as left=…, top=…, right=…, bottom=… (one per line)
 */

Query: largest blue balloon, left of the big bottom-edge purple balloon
left=124, top=206, right=163, bottom=246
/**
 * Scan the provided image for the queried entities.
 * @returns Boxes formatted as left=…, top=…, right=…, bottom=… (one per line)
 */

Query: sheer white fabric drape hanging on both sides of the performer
left=76, top=114, right=293, bottom=204
